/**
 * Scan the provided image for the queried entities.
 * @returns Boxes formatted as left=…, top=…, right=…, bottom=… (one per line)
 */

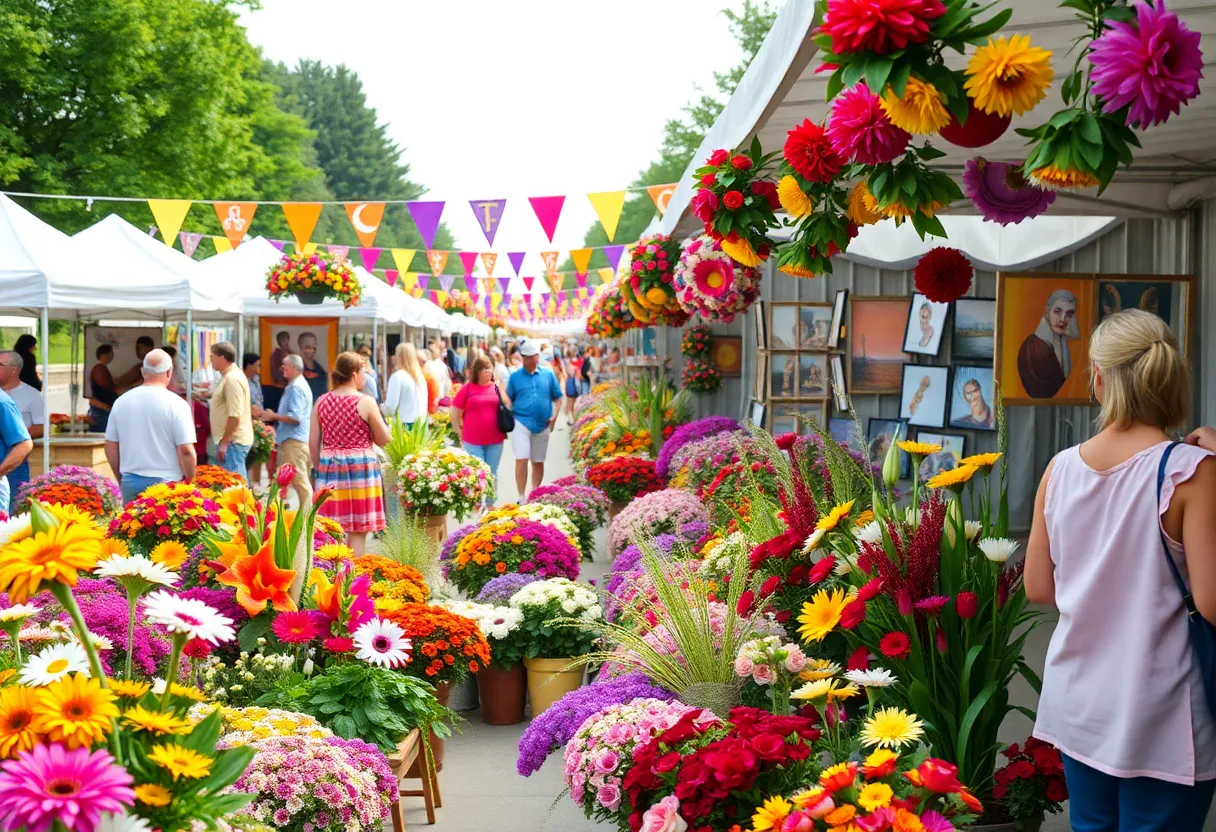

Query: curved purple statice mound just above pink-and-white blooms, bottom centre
left=516, top=673, right=675, bottom=777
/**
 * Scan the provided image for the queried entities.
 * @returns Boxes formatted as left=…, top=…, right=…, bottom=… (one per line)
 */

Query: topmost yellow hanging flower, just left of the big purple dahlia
left=963, top=35, right=1055, bottom=117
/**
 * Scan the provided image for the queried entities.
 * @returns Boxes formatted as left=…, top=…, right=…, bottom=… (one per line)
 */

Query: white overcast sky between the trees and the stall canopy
left=235, top=0, right=739, bottom=260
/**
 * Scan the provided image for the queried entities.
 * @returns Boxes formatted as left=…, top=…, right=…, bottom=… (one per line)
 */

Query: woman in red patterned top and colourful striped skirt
left=309, top=353, right=389, bottom=556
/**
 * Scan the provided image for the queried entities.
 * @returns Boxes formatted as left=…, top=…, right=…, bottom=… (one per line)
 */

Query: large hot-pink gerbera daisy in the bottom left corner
left=0, top=743, right=135, bottom=832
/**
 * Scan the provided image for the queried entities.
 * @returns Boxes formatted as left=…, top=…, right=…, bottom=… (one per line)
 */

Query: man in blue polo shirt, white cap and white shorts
left=507, top=338, right=562, bottom=500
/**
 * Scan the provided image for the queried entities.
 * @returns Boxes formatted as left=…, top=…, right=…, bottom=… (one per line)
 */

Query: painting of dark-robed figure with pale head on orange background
left=996, top=272, right=1096, bottom=405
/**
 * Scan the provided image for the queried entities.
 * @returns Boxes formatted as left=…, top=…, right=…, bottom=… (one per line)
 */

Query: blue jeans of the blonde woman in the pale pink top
left=1064, top=755, right=1216, bottom=832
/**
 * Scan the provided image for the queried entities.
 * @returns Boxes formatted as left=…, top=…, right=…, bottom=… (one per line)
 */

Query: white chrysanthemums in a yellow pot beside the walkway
left=511, top=578, right=603, bottom=716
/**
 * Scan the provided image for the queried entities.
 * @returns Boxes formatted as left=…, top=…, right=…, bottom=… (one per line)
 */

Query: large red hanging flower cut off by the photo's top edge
left=818, top=0, right=946, bottom=55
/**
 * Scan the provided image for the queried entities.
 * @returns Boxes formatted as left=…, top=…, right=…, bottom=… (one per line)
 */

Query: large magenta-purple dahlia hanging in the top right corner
left=1090, top=0, right=1204, bottom=128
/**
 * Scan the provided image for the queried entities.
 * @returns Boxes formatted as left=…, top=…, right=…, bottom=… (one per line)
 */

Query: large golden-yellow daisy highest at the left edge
left=0, top=523, right=101, bottom=603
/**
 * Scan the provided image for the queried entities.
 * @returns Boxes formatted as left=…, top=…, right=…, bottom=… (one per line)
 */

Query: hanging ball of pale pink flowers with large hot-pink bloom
left=675, top=234, right=760, bottom=325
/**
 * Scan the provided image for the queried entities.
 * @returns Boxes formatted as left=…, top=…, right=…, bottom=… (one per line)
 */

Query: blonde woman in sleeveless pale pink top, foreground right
left=1025, top=309, right=1216, bottom=832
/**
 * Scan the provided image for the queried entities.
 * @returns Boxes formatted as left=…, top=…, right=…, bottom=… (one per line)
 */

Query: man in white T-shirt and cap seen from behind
left=106, top=349, right=198, bottom=502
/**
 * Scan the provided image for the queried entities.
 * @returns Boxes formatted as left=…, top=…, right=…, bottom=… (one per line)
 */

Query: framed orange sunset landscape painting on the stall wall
left=849, top=298, right=912, bottom=395
